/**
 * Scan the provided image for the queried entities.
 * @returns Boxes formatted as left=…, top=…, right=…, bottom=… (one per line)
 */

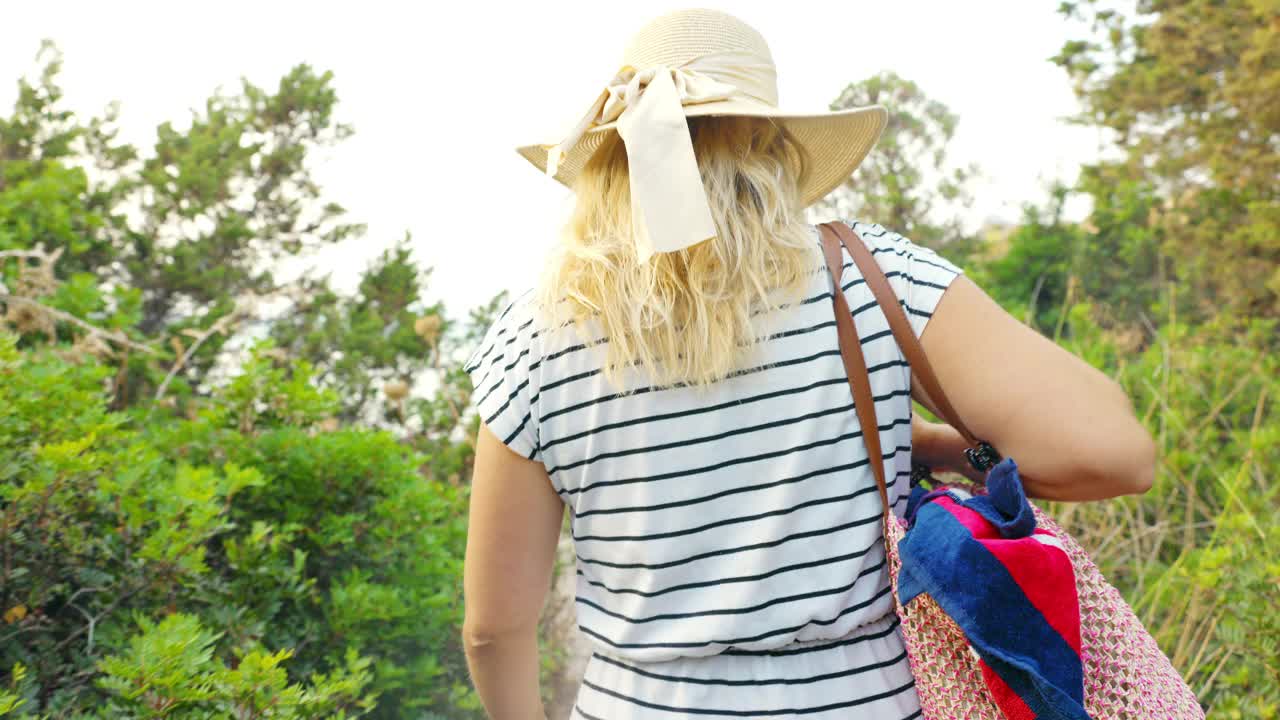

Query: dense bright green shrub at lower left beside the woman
left=0, top=336, right=475, bottom=719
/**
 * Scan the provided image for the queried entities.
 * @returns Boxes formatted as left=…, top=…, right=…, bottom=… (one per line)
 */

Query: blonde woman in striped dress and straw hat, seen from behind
left=463, top=10, right=1155, bottom=720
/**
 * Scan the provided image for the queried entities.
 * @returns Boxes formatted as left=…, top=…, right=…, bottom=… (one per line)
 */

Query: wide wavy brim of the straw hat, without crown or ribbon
left=516, top=100, right=888, bottom=208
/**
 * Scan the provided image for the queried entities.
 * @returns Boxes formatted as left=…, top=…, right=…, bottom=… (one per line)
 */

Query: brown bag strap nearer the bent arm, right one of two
left=824, top=222, right=983, bottom=447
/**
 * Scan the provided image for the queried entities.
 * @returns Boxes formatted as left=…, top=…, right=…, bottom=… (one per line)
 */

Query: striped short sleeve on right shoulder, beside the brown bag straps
left=849, top=222, right=963, bottom=337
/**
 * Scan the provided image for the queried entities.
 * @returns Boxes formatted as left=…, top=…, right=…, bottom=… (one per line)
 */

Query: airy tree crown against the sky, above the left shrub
left=129, top=60, right=361, bottom=334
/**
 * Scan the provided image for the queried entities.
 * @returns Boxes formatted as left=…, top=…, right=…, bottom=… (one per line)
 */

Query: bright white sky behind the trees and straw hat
left=0, top=0, right=1101, bottom=313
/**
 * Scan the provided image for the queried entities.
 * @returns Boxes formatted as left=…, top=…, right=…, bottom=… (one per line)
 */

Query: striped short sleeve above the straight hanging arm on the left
left=463, top=293, right=541, bottom=461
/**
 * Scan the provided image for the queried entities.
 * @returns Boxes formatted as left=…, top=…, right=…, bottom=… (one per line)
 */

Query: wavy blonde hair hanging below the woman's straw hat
left=539, top=117, right=819, bottom=386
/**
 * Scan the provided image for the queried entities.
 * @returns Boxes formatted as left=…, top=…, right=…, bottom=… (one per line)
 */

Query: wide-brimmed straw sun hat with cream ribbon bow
left=517, top=10, right=887, bottom=260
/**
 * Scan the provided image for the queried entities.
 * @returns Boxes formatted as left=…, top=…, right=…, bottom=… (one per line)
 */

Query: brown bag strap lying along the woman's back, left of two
left=818, top=225, right=890, bottom=519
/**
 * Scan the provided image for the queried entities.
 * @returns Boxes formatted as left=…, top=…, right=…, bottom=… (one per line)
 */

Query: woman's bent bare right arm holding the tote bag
left=914, top=275, right=1156, bottom=500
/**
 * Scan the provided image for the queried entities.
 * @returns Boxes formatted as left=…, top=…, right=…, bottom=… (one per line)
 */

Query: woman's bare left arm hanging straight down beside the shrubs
left=462, top=425, right=564, bottom=720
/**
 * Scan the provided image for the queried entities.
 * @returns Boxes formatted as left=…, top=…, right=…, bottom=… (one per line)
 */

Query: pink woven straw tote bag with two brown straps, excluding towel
left=819, top=223, right=1204, bottom=720
